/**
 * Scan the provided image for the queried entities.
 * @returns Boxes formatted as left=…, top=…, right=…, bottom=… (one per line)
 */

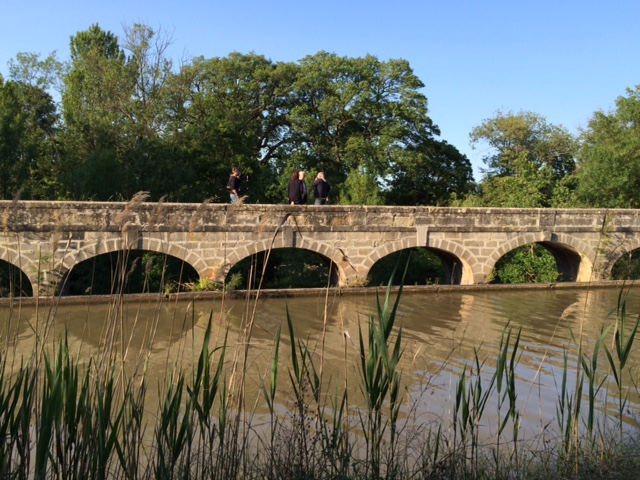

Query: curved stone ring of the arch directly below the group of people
left=222, top=236, right=349, bottom=286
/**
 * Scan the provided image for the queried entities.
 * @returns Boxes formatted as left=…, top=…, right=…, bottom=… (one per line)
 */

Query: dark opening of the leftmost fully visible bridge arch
left=56, top=249, right=200, bottom=296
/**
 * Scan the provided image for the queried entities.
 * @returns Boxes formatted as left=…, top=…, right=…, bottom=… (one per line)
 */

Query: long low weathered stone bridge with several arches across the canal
left=0, top=200, right=640, bottom=295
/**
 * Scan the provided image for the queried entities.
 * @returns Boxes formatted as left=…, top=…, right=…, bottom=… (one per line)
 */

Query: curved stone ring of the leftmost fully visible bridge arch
left=56, top=239, right=204, bottom=294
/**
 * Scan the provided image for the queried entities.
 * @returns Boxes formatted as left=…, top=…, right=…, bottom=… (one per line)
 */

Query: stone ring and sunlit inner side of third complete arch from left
left=364, top=240, right=476, bottom=285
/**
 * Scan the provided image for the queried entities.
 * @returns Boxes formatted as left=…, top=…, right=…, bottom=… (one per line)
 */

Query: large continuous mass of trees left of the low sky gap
left=2, top=23, right=472, bottom=204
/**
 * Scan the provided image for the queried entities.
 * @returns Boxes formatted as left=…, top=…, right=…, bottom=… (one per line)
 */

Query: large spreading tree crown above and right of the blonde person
left=288, top=52, right=440, bottom=202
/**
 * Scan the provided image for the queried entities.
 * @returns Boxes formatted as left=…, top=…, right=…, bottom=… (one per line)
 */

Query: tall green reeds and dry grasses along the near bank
left=0, top=276, right=640, bottom=479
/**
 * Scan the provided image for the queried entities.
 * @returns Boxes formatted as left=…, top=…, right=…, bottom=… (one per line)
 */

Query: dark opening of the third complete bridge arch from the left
left=367, top=247, right=452, bottom=286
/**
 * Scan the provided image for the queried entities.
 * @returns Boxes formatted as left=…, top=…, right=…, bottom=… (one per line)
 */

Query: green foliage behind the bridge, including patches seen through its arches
left=0, top=23, right=640, bottom=288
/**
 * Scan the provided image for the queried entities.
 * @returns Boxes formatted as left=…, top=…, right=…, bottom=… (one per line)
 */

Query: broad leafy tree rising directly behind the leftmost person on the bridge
left=168, top=53, right=295, bottom=202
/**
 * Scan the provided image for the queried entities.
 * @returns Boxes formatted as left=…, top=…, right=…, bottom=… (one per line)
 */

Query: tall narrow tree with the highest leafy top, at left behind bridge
left=62, top=25, right=132, bottom=200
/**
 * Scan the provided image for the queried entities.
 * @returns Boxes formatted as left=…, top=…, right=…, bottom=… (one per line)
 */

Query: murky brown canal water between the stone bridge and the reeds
left=0, top=287, right=640, bottom=442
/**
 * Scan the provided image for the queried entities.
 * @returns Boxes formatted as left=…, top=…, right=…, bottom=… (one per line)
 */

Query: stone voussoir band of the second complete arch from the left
left=221, top=235, right=349, bottom=285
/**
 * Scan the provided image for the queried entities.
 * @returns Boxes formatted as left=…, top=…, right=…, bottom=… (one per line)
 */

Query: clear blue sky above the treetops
left=0, top=0, right=640, bottom=179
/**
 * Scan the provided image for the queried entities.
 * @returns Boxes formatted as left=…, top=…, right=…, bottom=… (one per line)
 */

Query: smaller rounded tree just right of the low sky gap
left=464, top=111, right=577, bottom=207
